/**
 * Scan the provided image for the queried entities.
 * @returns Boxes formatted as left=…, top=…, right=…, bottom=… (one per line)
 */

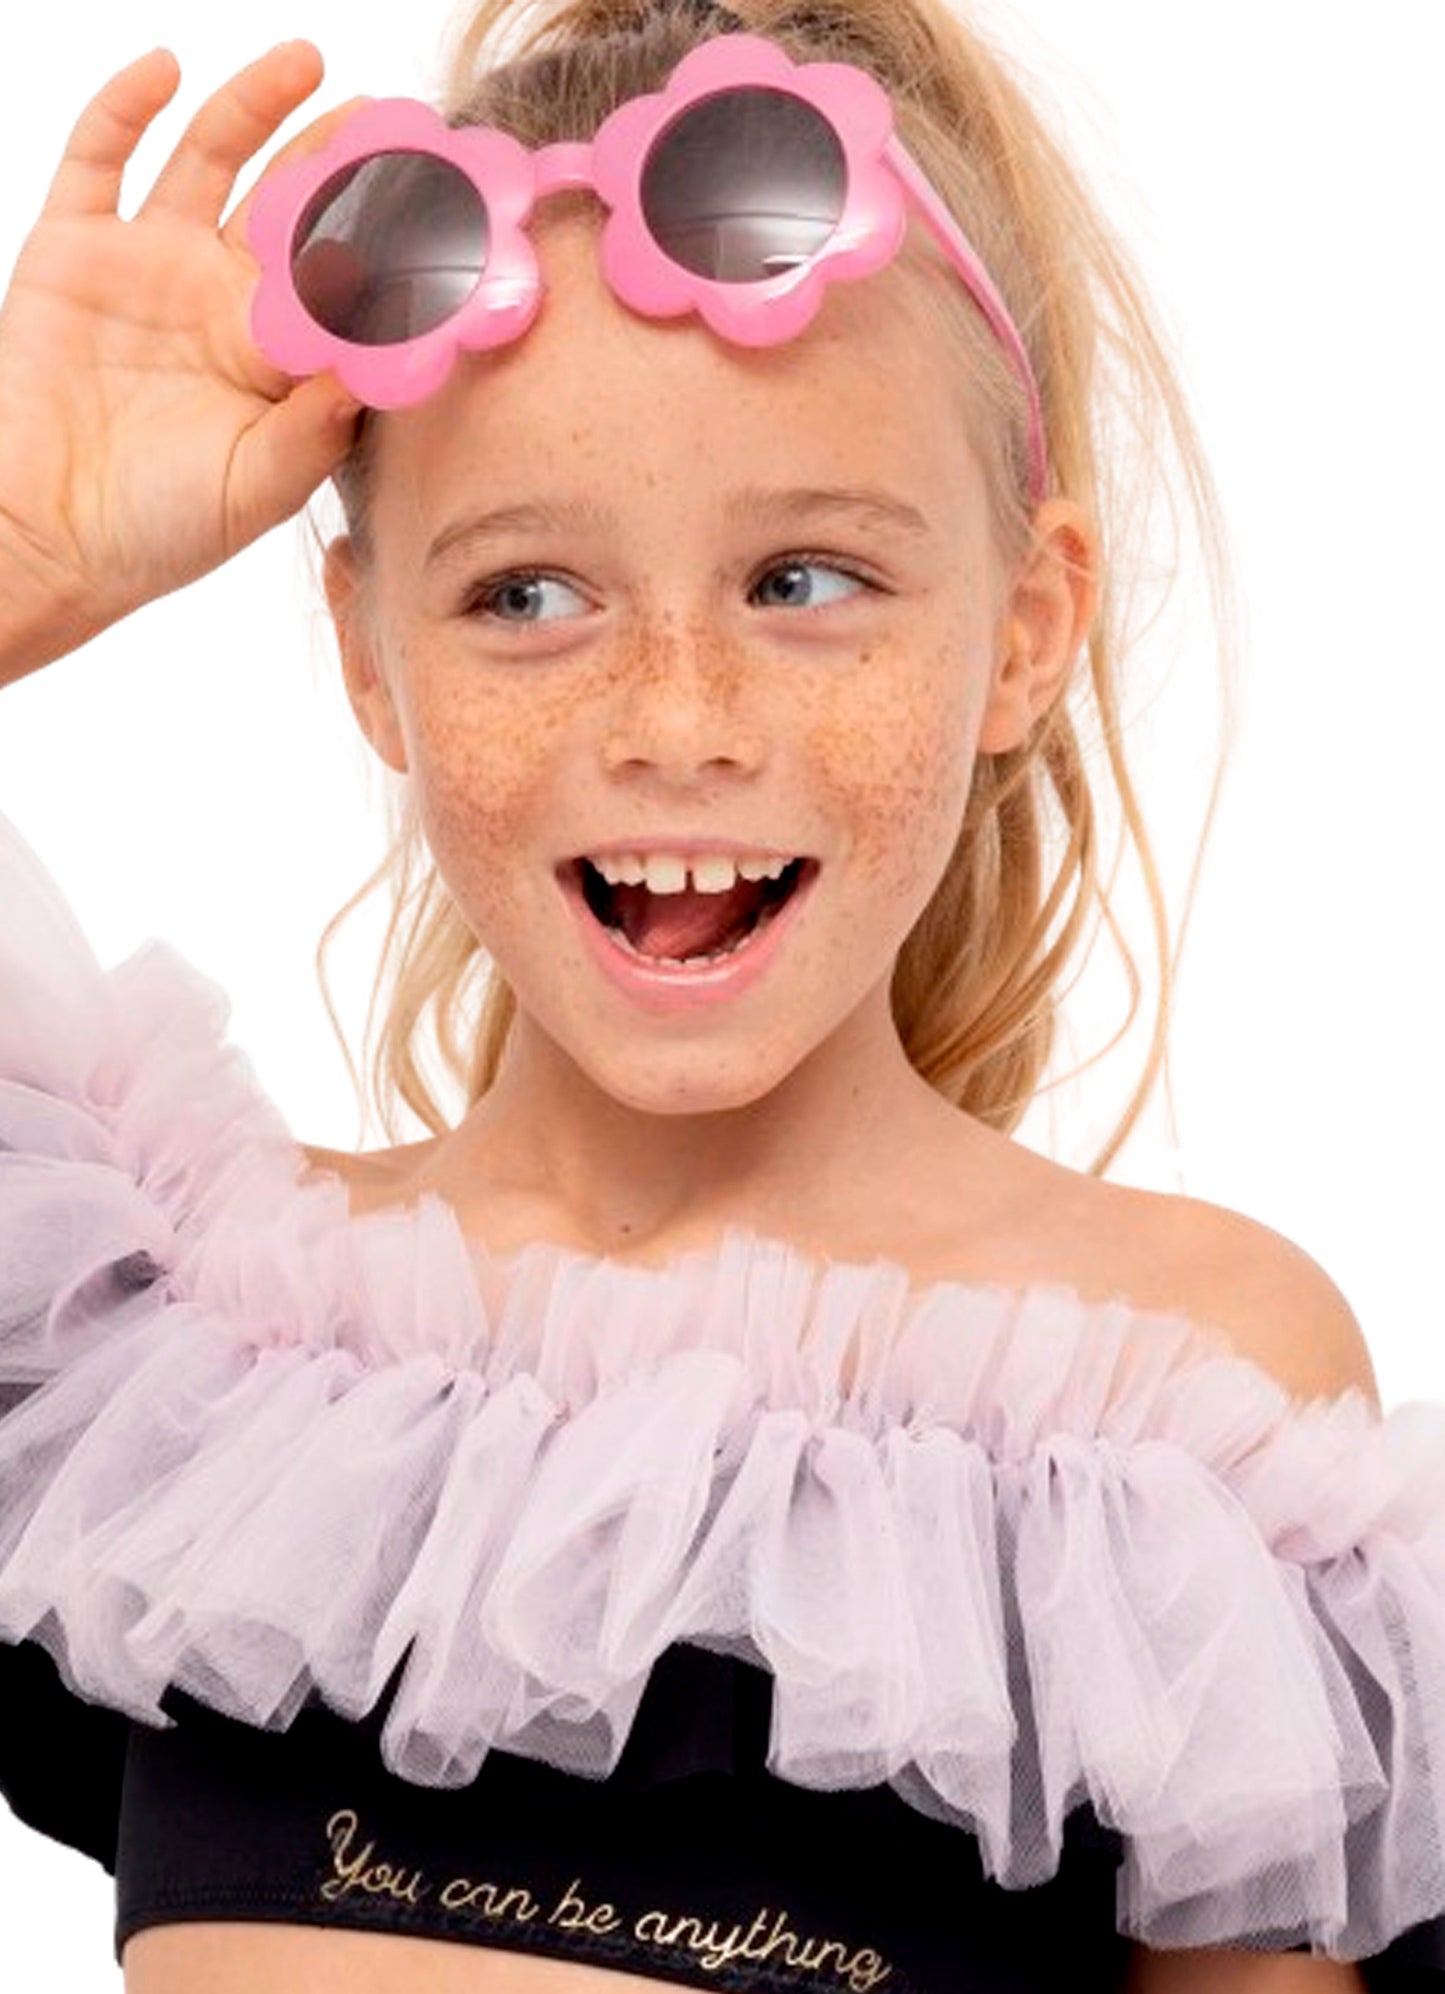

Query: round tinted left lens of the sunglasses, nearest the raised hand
left=291, top=152, right=490, bottom=347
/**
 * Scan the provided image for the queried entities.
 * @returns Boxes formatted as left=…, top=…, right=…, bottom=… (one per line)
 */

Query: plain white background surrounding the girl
left=0, top=0, right=1445, bottom=1990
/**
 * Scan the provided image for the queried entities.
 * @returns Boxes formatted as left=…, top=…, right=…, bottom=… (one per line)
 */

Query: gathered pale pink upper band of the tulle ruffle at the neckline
left=197, top=1108, right=1291, bottom=1458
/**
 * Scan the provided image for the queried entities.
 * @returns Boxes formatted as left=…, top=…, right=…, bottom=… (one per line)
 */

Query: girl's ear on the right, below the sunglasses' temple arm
left=977, top=499, right=1098, bottom=754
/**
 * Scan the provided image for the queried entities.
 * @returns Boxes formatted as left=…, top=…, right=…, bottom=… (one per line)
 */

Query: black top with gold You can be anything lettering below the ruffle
left=0, top=1645, right=1128, bottom=1994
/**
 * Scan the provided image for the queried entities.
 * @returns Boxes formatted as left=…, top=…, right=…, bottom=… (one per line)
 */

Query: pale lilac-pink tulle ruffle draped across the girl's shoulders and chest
left=0, top=818, right=1445, bottom=1960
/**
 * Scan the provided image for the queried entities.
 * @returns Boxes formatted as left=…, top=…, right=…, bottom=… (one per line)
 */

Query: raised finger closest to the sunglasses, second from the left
left=138, top=42, right=323, bottom=225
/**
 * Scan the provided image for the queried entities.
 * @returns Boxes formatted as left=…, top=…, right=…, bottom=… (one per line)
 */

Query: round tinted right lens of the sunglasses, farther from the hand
left=642, top=90, right=847, bottom=283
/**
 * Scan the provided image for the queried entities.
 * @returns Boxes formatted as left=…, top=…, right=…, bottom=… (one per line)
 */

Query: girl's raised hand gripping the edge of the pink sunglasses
left=0, top=42, right=361, bottom=678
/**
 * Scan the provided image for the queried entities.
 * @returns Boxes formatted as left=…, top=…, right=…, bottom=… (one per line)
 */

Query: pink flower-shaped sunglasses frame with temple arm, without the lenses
left=247, top=34, right=1048, bottom=504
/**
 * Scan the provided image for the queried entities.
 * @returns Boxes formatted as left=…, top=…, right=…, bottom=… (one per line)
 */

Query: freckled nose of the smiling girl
left=602, top=634, right=767, bottom=784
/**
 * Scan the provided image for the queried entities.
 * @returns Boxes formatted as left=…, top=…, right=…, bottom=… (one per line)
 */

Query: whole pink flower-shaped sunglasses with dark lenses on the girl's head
left=249, top=34, right=1046, bottom=504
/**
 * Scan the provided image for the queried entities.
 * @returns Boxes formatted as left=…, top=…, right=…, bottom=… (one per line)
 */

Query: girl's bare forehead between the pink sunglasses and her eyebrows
left=375, top=223, right=977, bottom=530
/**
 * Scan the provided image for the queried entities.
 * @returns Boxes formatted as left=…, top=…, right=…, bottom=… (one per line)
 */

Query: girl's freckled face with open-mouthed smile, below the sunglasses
left=344, top=221, right=1003, bottom=1113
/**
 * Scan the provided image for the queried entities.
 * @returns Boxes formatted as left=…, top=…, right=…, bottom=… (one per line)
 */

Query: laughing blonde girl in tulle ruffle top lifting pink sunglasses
left=0, top=0, right=1445, bottom=1994
